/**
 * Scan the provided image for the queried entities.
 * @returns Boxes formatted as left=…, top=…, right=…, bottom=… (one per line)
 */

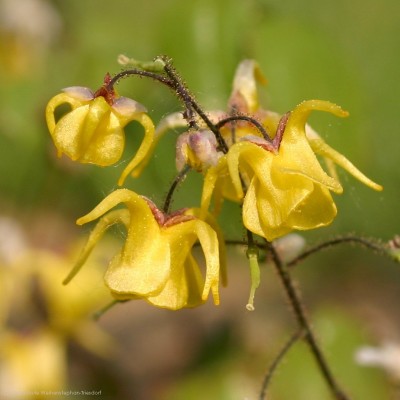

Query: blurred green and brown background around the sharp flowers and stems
left=0, top=0, right=400, bottom=400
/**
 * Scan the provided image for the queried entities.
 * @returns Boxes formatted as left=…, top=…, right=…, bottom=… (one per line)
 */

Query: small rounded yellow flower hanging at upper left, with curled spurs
left=46, top=75, right=154, bottom=185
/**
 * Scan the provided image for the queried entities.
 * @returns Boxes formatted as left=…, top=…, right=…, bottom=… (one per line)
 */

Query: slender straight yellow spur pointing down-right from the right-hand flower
left=309, top=139, right=383, bottom=191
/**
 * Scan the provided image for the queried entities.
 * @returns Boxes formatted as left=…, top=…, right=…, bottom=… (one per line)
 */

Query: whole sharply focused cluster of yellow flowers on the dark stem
left=46, top=60, right=382, bottom=310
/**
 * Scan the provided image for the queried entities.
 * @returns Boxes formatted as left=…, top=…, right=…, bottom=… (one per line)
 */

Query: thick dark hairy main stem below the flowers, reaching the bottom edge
left=267, top=242, right=349, bottom=400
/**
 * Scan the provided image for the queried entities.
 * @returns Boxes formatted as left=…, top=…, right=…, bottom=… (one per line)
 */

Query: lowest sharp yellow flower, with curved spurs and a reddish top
left=64, top=189, right=224, bottom=310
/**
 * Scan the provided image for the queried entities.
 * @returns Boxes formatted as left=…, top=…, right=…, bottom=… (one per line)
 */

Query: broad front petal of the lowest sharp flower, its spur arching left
left=77, top=189, right=170, bottom=299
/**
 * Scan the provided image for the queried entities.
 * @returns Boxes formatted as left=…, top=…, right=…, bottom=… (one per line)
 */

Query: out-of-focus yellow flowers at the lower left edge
left=0, top=222, right=117, bottom=399
